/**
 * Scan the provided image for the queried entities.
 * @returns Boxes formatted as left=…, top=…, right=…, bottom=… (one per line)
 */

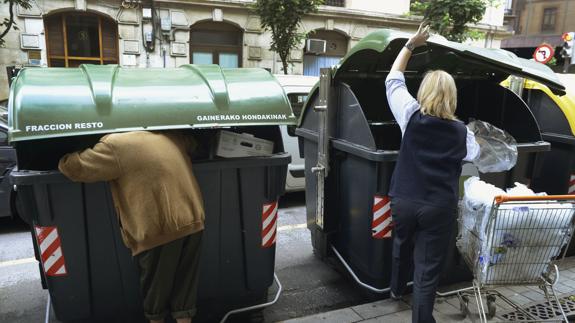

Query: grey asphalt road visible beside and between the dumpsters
left=0, top=193, right=368, bottom=323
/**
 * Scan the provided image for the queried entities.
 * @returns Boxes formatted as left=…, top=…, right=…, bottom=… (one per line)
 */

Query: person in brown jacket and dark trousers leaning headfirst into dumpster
left=58, top=131, right=204, bottom=323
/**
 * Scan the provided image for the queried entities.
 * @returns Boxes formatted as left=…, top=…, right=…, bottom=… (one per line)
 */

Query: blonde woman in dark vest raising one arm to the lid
left=385, top=23, right=479, bottom=322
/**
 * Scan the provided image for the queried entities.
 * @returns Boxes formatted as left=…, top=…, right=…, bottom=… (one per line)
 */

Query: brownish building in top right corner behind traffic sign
left=501, top=0, right=575, bottom=63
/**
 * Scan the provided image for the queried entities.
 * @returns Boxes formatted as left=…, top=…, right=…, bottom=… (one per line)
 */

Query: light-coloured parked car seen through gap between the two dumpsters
left=275, top=74, right=319, bottom=192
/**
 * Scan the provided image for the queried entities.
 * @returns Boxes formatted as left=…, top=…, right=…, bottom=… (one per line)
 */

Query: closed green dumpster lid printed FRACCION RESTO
left=8, top=65, right=296, bottom=141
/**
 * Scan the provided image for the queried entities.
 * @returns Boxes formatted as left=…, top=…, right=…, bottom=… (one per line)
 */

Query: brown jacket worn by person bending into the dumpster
left=58, top=131, right=204, bottom=255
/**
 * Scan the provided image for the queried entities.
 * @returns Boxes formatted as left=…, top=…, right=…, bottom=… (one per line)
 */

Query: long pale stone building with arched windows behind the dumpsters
left=0, top=0, right=506, bottom=100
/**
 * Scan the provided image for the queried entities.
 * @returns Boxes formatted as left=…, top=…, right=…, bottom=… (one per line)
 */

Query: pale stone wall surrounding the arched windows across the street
left=0, top=0, right=508, bottom=100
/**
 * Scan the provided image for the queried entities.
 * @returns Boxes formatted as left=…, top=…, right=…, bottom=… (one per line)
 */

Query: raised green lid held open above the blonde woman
left=335, top=29, right=565, bottom=94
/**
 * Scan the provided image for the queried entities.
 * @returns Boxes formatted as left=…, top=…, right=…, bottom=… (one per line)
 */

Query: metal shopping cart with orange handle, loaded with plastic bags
left=438, top=195, right=575, bottom=322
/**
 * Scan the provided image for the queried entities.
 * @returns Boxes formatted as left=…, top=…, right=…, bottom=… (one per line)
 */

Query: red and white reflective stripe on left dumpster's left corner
left=34, top=226, right=68, bottom=276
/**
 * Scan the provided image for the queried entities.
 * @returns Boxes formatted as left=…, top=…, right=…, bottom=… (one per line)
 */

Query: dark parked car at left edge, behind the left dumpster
left=0, top=101, right=16, bottom=218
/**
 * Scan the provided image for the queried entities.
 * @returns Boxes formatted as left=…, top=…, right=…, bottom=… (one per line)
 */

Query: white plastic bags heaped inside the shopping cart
left=457, top=176, right=574, bottom=283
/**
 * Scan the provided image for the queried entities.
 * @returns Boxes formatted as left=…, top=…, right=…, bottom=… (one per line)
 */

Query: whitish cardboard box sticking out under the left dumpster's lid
left=216, top=130, right=274, bottom=158
